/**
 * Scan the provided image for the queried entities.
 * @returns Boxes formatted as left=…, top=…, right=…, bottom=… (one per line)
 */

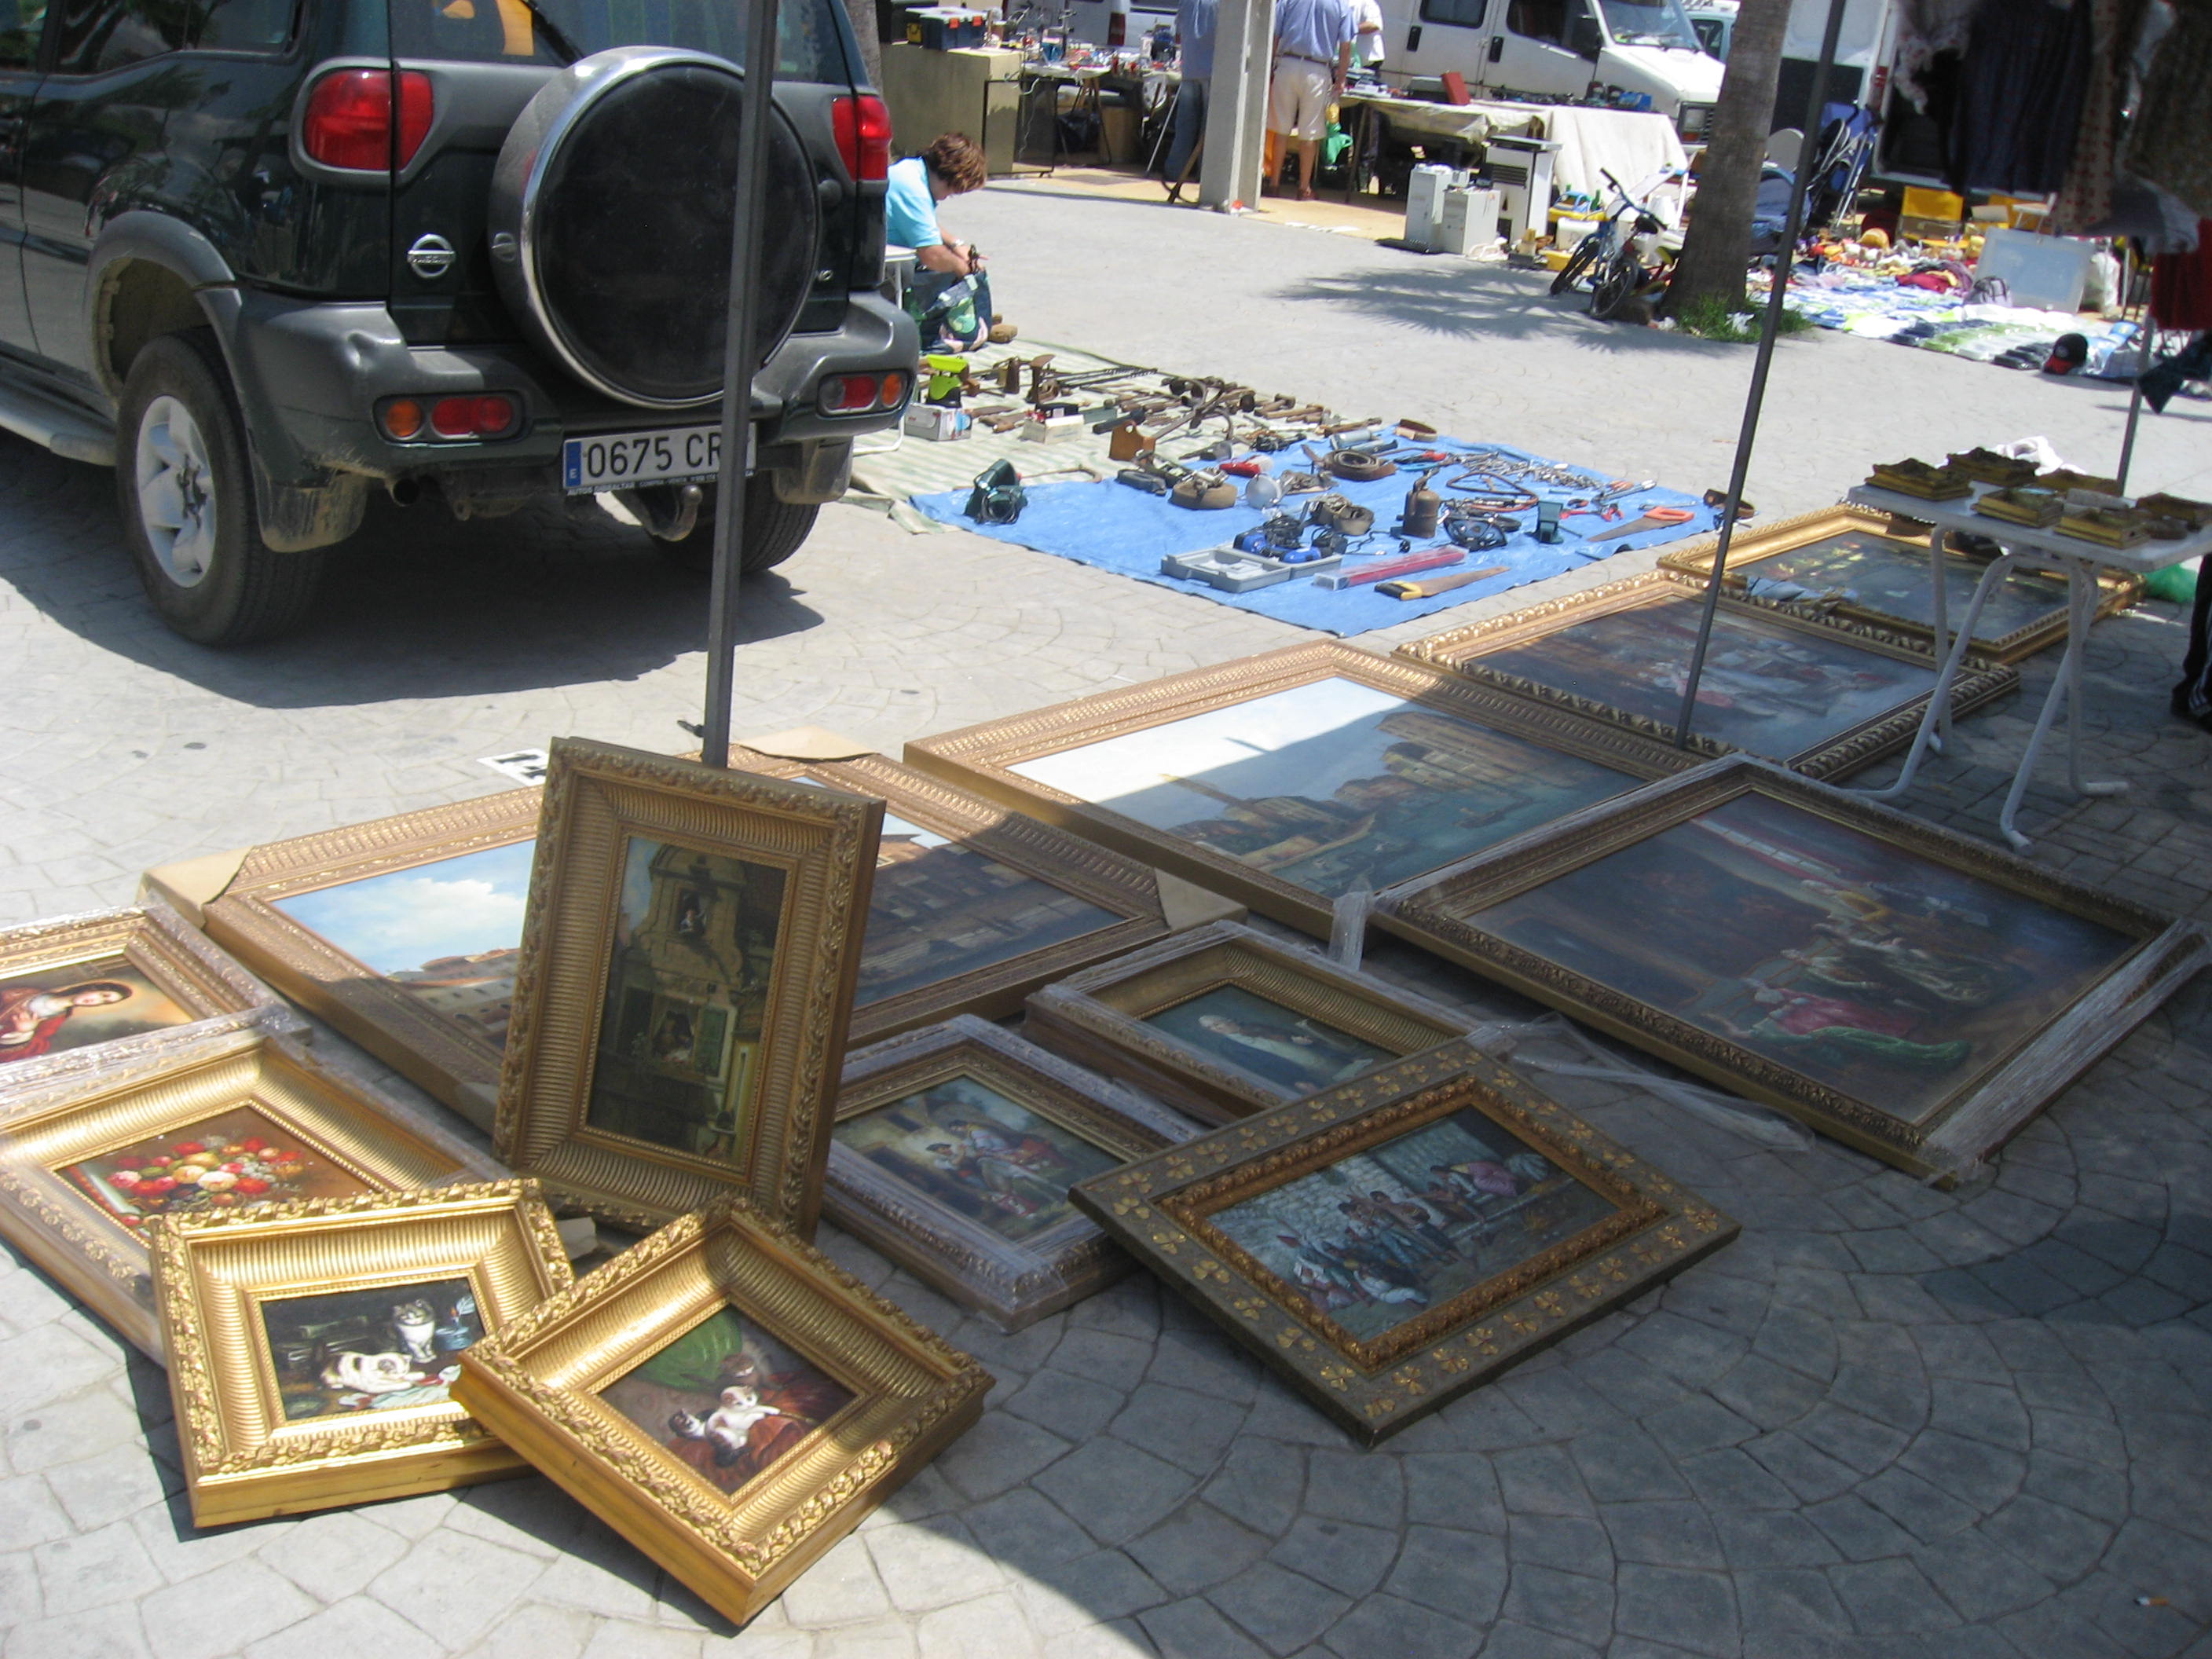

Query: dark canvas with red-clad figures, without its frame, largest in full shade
left=1471, top=797, right=2134, bottom=1122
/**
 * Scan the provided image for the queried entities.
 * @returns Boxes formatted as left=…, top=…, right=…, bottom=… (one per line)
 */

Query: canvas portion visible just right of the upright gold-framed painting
left=856, top=811, right=1122, bottom=1009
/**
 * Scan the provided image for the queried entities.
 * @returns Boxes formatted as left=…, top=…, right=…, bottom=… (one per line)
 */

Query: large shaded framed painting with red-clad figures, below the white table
left=1380, top=759, right=2207, bottom=1179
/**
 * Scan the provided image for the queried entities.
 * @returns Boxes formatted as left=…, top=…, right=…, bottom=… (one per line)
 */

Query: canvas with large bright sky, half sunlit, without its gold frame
left=1013, top=679, right=1639, bottom=898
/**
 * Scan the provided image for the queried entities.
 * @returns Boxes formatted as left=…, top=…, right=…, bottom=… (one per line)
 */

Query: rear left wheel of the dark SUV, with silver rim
left=115, top=330, right=323, bottom=646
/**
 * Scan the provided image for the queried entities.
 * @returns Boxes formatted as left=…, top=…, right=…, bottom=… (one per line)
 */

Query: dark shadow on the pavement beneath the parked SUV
left=0, top=434, right=821, bottom=708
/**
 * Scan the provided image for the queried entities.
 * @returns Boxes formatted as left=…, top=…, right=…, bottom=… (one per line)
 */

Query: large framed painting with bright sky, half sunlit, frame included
left=905, top=642, right=1719, bottom=938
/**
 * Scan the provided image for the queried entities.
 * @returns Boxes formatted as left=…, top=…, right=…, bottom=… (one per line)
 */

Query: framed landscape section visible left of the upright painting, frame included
left=191, top=789, right=544, bottom=1133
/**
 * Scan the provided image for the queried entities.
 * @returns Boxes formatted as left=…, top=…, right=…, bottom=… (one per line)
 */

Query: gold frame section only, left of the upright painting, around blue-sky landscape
left=201, top=789, right=544, bottom=1133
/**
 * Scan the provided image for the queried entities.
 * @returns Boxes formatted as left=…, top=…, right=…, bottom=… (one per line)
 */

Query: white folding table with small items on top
left=1847, top=485, right=2212, bottom=851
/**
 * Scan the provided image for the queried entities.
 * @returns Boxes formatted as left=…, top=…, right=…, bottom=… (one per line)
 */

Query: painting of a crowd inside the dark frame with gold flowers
left=1206, top=1111, right=1615, bottom=1342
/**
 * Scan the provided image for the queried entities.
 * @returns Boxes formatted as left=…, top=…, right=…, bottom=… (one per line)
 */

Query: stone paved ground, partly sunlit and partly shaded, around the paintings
left=0, top=190, right=2212, bottom=1659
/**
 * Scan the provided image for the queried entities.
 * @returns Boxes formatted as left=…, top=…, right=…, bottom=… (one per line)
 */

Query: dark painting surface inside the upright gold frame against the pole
left=584, top=836, right=786, bottom=1159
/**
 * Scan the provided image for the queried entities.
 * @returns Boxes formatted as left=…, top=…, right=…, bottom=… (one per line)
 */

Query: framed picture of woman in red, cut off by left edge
left=0, top=900, right=307, bottom=1108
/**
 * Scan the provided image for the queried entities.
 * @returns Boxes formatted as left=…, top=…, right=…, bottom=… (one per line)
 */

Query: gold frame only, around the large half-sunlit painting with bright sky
left=905, top=642, right=1721, bottom=938
